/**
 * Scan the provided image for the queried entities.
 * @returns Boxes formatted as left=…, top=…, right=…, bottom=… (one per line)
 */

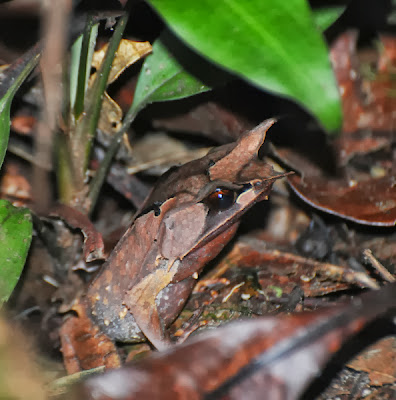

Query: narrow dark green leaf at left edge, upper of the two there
left=0, top=45, right=40, bottom=168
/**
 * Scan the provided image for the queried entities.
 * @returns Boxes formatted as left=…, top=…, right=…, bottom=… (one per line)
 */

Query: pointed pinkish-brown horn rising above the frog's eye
left=209, top=118, right=276, bottom=180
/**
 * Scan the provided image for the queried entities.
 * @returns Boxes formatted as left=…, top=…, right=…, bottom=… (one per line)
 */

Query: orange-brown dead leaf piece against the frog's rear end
left=59, top=301, right=121, bottom=374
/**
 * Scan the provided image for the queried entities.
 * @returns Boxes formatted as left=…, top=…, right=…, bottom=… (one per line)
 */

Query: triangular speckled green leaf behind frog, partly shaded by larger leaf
left=132, top=39, right=211, bottom=117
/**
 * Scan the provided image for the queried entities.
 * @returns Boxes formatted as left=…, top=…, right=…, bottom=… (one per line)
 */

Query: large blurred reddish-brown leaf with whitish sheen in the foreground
left=75, top=284, right=396, bottom=400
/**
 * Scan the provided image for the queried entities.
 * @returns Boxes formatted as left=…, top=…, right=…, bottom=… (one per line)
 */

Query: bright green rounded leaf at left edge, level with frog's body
left=0, top=200, right=32, bottom=305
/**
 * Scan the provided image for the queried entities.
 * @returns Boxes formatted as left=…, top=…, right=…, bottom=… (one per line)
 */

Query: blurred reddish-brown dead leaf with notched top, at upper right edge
left=331, top=31, right=396, bottom=133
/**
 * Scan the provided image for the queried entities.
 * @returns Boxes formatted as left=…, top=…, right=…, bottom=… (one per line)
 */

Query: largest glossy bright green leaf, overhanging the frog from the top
left=149, top=0, right=341, bottom=131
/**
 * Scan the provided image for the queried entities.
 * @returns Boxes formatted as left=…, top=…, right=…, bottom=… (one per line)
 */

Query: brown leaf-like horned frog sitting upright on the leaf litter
left=60, top=118, right=285, bottom=373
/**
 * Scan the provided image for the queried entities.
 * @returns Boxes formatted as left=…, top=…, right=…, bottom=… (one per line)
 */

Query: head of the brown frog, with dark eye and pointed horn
left=152, top=119, right=285, bottom=266
